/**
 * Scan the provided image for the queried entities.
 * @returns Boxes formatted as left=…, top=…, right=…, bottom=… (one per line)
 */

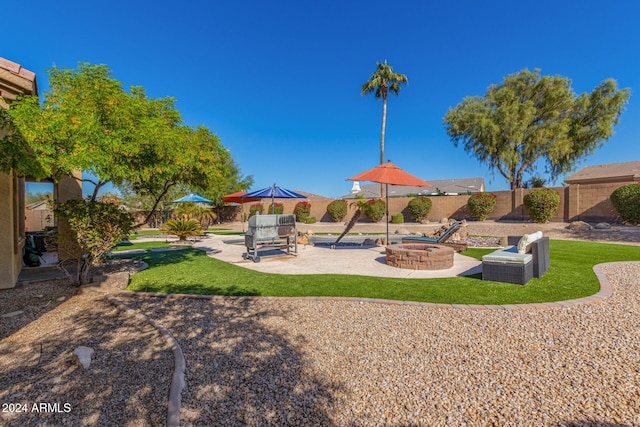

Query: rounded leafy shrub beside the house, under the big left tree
left=54, top=199, right=133, bottom=286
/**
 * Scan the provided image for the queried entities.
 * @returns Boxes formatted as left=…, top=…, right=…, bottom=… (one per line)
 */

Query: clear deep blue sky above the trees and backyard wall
left=5, top=0, right=640, bottom=197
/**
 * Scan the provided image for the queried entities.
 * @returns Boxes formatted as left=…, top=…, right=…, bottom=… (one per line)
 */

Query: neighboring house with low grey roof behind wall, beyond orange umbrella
left=341, top=178, right=485, bottom=199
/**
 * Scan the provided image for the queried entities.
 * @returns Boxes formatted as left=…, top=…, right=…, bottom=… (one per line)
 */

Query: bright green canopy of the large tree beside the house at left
left=0, top=63, right=251, bottom=224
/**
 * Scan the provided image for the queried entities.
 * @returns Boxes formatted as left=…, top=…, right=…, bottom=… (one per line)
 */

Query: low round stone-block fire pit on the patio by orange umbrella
left=387, top=243, right=454, bottom=270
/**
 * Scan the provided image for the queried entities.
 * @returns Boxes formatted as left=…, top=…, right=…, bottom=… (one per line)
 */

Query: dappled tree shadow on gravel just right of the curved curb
left=123, top=297, right=342, bottom=426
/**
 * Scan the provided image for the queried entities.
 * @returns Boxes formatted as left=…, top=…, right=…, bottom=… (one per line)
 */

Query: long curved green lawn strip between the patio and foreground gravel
left=116, top=240, right=640, bottom=304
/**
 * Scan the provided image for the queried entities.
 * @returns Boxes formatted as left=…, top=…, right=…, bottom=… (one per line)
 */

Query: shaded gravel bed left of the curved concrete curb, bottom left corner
left=0, top=264, right=174, bottom=427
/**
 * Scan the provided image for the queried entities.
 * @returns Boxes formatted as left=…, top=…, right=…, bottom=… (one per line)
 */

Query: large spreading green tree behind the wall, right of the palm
left=444, top=70, right=630, bottom=189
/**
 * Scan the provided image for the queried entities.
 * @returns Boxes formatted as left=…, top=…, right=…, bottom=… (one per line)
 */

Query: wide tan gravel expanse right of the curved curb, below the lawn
left=119, top=262, right=640, bottom=426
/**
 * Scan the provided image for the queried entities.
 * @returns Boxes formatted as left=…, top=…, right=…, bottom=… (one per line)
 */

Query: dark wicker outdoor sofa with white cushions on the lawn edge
left=482, top=231, right=551, bottom=285
